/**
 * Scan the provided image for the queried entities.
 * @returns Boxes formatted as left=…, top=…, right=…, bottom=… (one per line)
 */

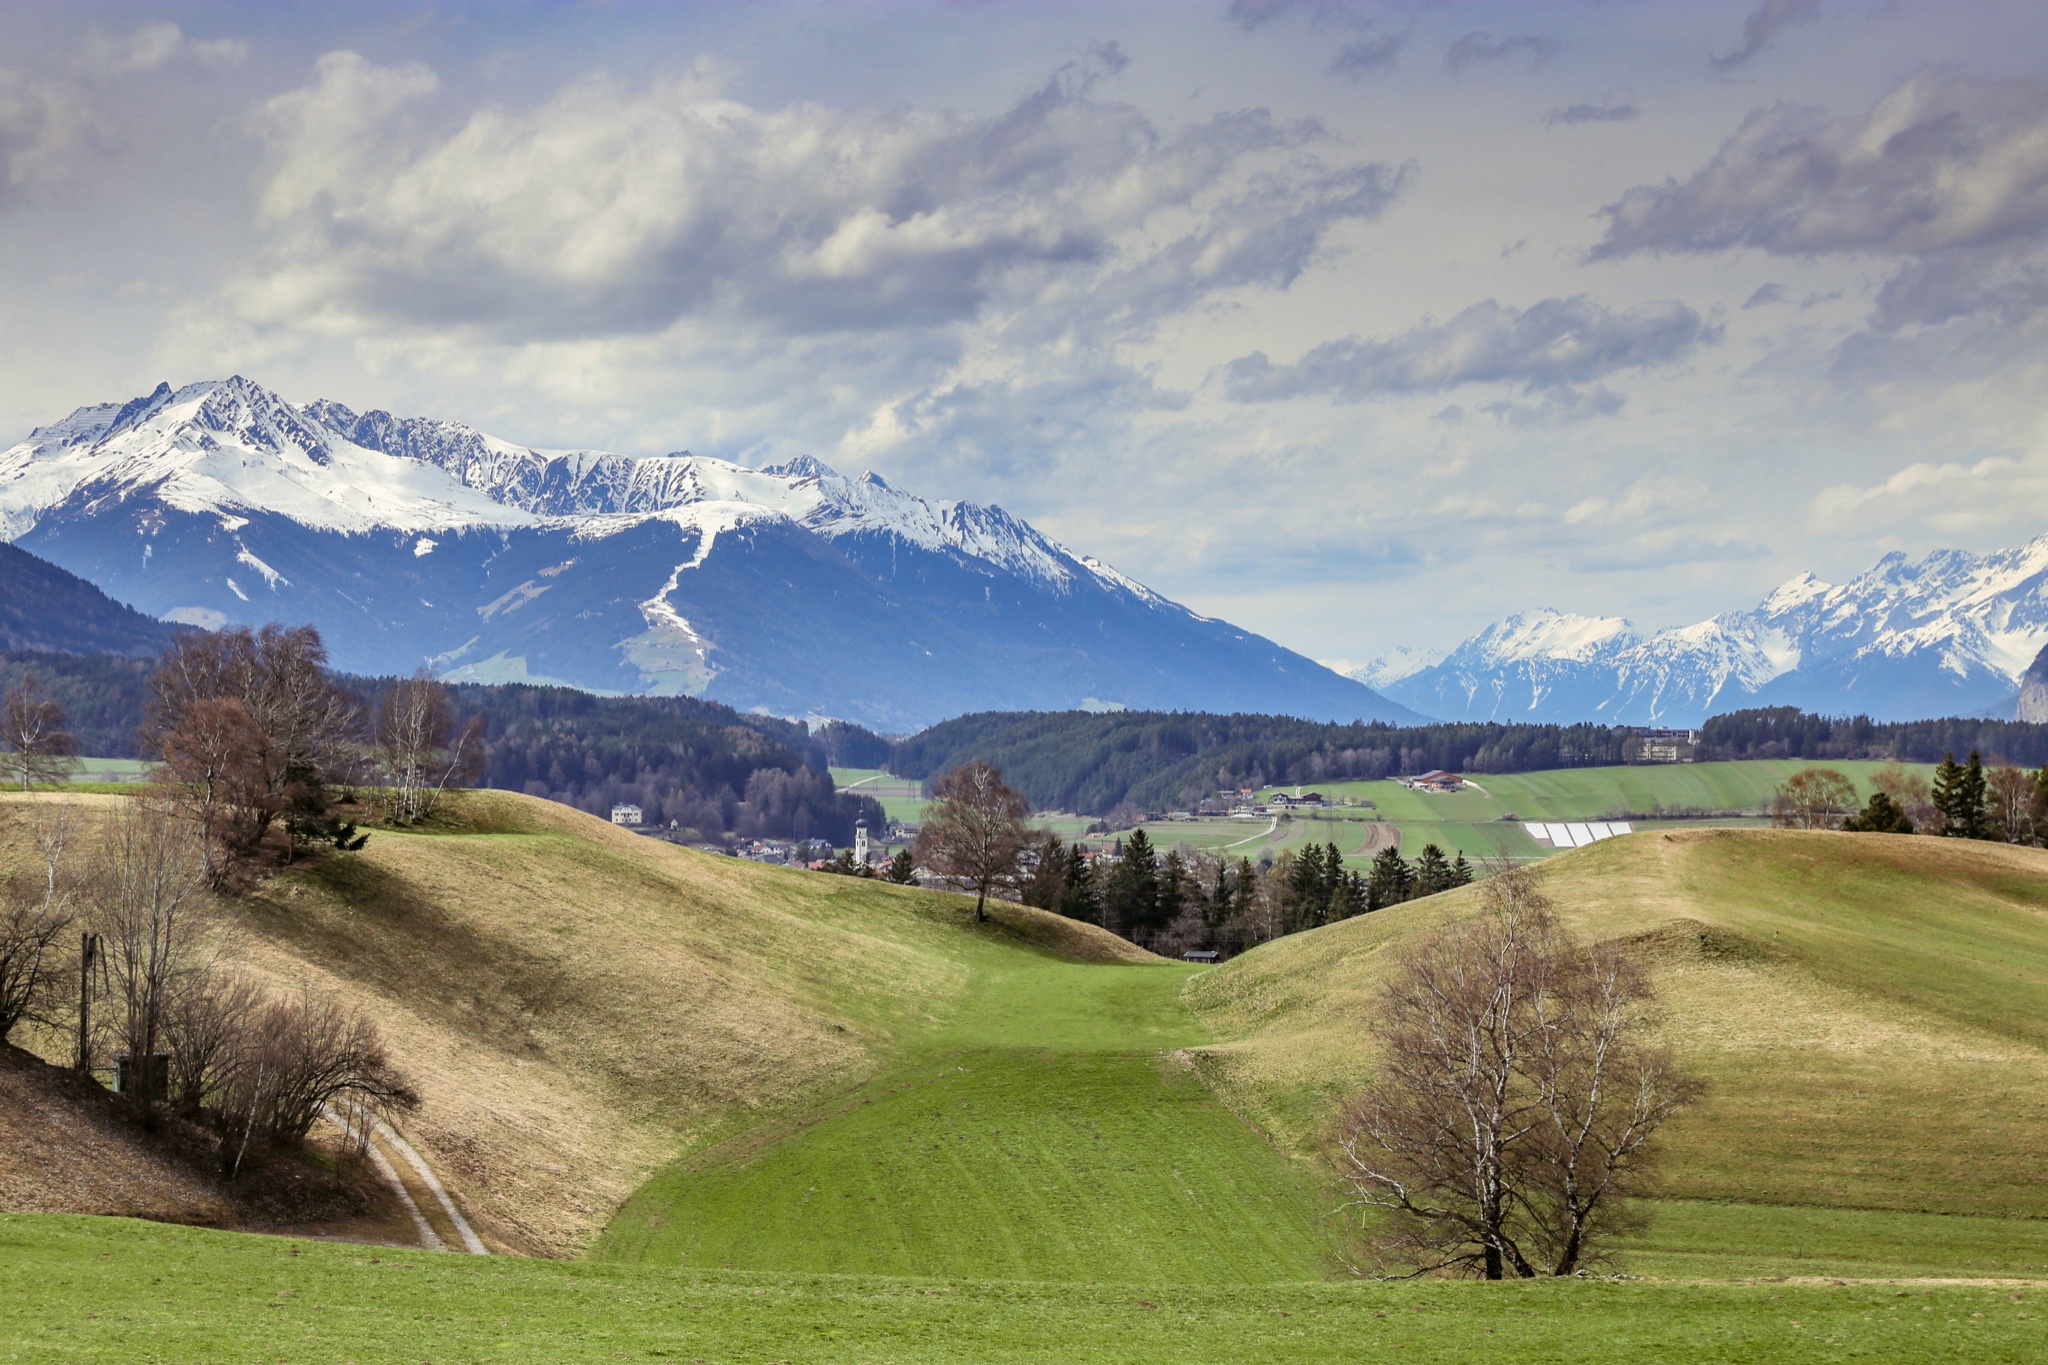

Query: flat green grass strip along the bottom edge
left=0, top=1216, right=2048, bottom=1365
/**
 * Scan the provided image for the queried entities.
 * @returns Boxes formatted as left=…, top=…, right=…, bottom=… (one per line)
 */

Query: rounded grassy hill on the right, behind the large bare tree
left=1188, top=831, right=2048, bottom=1269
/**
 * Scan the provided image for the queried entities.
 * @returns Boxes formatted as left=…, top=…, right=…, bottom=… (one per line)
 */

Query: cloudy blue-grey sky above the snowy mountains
left=0, top=0, right=2048, bottom=661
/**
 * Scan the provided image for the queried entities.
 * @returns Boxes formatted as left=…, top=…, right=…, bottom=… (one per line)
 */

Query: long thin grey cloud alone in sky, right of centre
left=1223, top=295, right=1720, bottom=403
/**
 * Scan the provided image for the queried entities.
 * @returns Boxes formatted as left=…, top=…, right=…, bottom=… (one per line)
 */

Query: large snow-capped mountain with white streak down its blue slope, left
left=0, top=377, right=1411, bottom=731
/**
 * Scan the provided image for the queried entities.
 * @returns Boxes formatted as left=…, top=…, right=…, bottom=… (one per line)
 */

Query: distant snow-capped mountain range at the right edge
left=1378, top=536, right=2048, bottom=724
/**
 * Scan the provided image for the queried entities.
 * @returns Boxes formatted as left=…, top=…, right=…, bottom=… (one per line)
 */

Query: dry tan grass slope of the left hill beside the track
left=0, top=792, right=1143, bottom=1254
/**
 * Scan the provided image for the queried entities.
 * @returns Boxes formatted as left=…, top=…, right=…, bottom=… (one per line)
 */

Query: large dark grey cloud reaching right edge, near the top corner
left=1591, top=74, right=2048, bottom=260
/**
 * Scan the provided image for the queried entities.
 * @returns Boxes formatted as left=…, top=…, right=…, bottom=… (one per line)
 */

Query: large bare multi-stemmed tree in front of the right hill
left=1339, top=868, right=1698, bottom=1279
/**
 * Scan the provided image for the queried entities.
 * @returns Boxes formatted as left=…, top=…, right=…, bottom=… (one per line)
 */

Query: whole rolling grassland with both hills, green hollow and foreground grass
left=0, top=792, right=2048, bottom=1361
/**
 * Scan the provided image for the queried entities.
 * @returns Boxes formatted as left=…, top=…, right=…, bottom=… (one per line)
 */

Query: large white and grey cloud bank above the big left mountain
left=236, top=45, right=1401, bottom=344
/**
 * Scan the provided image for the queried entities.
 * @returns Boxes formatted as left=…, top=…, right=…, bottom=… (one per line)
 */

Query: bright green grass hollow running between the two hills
left=598, top=941, right=1333, bottom=1283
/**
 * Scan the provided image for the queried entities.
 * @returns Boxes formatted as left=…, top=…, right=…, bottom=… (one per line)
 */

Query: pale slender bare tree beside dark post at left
left=90, top=800, right=221, bottom=1107
